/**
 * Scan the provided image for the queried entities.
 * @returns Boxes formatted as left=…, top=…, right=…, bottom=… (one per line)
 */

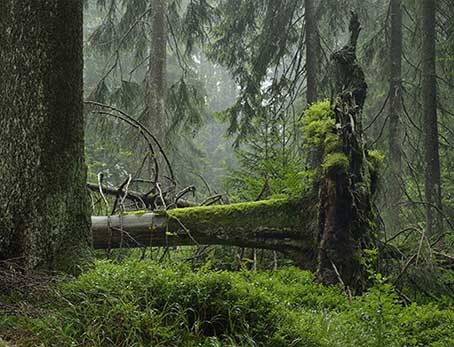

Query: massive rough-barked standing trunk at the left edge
left=0, top=0, right=90, bottom=268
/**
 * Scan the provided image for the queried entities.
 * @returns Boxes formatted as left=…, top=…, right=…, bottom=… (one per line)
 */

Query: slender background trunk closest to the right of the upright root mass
left=389, top=0, right=403, bottom=232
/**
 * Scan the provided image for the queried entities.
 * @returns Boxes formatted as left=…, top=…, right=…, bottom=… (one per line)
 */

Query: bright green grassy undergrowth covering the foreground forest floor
left=0, top=260, right=454, bottom=347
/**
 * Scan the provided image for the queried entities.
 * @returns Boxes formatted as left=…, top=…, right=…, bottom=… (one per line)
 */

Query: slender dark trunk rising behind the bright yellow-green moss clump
left=304, top=0, right=319, bottom=105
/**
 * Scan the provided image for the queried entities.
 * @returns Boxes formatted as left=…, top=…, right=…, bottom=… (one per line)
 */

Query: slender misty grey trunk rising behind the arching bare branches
left=145, top=0, right=167, bottom=177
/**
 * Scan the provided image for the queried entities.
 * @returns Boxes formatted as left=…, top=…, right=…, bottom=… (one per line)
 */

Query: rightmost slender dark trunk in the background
left=421, top=0, right=442, bottom=236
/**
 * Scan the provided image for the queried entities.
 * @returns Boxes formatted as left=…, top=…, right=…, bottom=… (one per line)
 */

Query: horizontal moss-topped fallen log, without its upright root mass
left=92, top=199, right=318, bottom=269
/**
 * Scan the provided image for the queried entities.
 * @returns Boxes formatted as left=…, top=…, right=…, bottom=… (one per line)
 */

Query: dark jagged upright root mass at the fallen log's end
left=317, top=14, right=371, bottom=292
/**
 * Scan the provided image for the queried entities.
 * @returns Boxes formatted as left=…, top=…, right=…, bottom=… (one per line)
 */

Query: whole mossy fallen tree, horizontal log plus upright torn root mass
left=88, top=14, right=379, bottom=293
